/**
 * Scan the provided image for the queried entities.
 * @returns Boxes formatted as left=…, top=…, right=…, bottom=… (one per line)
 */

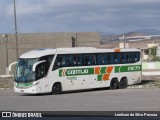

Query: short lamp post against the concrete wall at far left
left=2, top=34, right=9, bottom=75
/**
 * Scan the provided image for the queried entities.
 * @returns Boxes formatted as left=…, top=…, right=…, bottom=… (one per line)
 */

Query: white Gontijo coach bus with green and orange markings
left=14, top=47, right=142, bottom=94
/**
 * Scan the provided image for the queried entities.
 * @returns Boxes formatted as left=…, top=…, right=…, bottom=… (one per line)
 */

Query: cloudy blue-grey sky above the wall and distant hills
left=0, top=0, right=160, bottom=34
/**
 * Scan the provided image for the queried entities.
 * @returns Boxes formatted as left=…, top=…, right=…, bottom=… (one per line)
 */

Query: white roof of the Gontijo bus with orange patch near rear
left=20, top=47, right=140, bottom=58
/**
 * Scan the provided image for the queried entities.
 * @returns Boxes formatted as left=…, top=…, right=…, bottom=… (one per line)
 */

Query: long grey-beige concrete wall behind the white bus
left=0, top=32, right=100, bottom=75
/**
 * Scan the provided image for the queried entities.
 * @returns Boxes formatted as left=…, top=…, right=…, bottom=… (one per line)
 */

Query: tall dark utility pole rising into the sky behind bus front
left=14, top=0, right=19, bottom=60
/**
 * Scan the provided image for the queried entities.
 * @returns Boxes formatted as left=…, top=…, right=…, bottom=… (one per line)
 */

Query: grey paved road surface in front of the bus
left=0, top=89, right=160, bottom=111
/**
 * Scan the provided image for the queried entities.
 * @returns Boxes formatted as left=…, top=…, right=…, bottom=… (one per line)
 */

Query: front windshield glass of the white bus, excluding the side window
left=15, top=58, right=38, bottom=82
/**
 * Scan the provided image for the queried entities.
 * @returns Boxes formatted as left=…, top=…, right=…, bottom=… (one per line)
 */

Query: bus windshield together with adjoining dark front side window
left=15, top=55, right=54, bottom=83
